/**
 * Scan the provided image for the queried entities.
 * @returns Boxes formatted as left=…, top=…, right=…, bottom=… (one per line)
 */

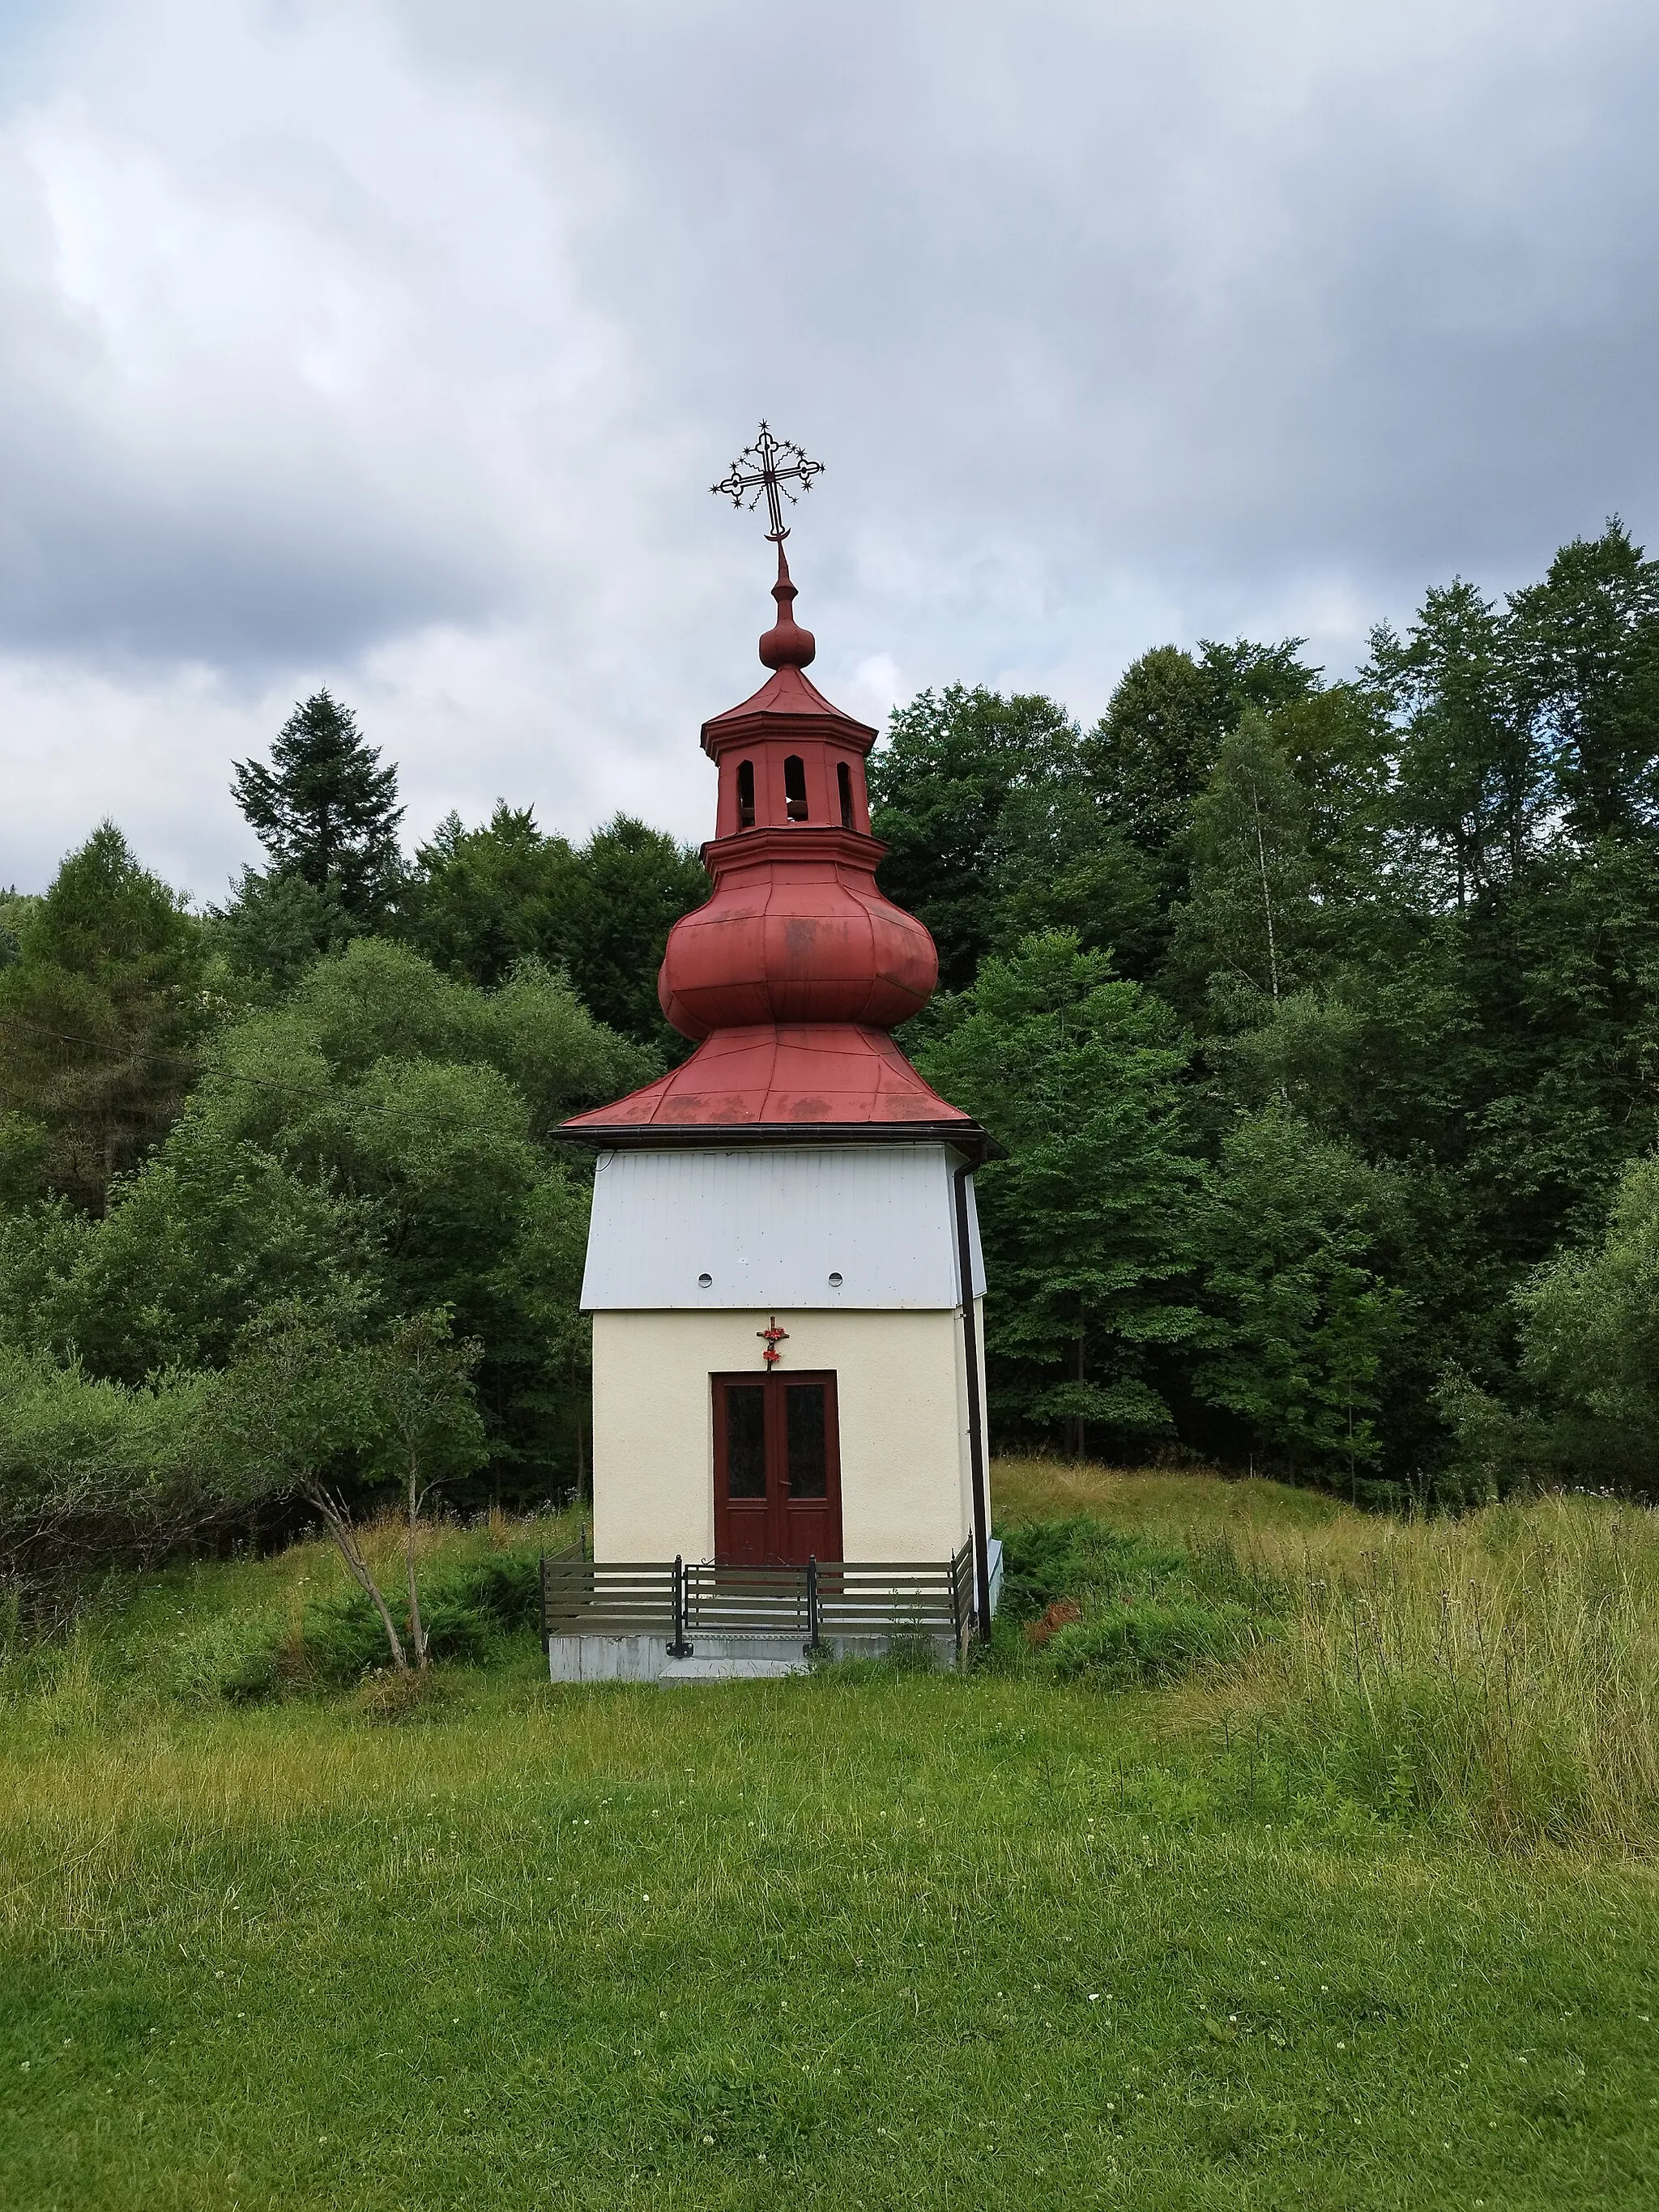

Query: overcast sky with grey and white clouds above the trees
left=0, top=0, right=1659, bottom=901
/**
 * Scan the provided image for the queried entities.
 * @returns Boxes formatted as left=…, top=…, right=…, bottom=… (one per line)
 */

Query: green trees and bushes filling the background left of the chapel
left=0, top=693, right=708, bottom=1571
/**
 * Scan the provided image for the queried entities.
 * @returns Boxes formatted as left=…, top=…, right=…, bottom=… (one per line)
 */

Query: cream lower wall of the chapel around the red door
left=593, top=1301, right=984, bottom=1559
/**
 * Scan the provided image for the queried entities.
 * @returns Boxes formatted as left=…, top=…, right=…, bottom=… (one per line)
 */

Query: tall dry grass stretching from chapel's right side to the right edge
left=1002, top=1462, right=1659, bottom=1854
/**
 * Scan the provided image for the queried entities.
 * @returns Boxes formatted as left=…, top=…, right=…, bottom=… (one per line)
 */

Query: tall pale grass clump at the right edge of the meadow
left=1235, top=1498, right=1659, bottom=1852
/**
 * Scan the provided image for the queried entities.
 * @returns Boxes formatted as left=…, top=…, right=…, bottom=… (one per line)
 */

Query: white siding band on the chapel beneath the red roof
left=582, top=1144, right=984, bottom=1311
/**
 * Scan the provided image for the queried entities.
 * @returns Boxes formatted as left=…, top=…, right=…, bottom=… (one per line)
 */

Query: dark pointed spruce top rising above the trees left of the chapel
left=230, top=690, right=403, bottom=918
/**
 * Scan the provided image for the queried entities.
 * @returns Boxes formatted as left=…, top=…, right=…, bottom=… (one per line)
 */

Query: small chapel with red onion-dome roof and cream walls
left=564, top=424, right=993, bottom=1663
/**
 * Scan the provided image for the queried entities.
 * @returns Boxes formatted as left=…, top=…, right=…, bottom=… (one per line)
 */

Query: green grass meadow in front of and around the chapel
left=0, top=1462, right=1659, bottom=2212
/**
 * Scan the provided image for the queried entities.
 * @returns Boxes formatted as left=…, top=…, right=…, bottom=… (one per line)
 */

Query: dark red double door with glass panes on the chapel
left=710, top=1369, right=841, bottom=1566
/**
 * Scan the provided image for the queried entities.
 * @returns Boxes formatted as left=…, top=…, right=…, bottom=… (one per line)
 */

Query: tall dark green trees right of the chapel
left=898, top=522, right=1659, bottom=1500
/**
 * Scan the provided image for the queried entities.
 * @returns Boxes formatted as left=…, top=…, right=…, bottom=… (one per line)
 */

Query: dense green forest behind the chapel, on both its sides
left=0, top=522, right=1659, bottom=1568
